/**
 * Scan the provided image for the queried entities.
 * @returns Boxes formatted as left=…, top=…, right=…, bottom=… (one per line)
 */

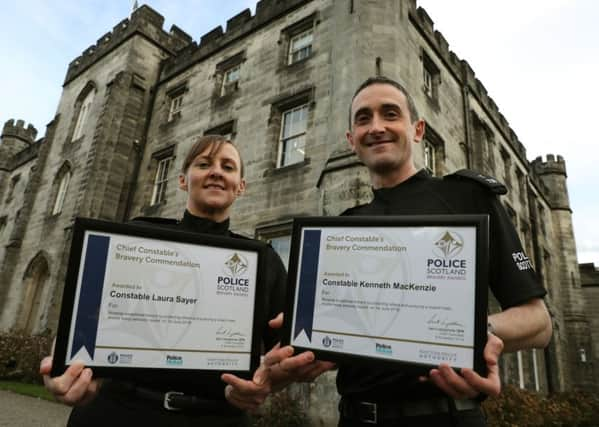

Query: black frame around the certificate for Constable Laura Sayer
left=51, top=218, right=267, bottom=384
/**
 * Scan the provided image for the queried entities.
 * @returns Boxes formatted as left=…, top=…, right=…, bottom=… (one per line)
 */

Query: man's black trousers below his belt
left=339, top=408, right=487, bottom=427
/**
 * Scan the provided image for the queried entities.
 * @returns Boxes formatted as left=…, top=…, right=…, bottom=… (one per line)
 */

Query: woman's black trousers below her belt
left=67, top=393, right=249, bottom=427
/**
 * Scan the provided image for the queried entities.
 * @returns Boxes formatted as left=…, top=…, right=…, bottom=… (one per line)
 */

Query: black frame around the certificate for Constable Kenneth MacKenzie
left=282, top=215, right=489, bottom=376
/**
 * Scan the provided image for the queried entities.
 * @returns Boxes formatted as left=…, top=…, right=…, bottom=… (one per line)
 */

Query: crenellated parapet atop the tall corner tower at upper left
left=64, top=5, right=192, bottom=86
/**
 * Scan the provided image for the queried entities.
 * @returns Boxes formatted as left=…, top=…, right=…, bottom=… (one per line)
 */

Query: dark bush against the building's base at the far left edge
left=0, top=331, right=52, bottom=383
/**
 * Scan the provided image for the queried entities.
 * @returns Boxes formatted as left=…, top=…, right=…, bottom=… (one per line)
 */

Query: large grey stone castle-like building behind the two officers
left=0, top=0, right=599, bottom=422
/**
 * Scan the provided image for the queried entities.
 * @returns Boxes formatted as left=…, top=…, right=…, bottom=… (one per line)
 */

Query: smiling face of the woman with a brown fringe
left=179, top=143, right=245, bottom=222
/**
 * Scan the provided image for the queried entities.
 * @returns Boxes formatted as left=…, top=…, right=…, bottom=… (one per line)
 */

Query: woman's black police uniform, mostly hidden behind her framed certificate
left=68, top=211, right=287, bottom=427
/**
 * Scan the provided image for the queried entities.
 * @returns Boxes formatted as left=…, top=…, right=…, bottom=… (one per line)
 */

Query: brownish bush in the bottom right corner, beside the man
left=483, top=385, right=599, bottom=427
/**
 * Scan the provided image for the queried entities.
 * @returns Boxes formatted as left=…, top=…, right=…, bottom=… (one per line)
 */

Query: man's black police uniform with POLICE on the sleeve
left=337, top=170, right=545, bottom=427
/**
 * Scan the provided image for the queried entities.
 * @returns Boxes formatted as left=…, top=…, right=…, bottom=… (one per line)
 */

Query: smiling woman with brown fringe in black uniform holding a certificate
left=40, top=135, right=291, bottom=427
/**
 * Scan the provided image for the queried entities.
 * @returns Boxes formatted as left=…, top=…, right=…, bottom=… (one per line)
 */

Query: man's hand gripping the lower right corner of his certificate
left=429, top=334, right=503, bottom=399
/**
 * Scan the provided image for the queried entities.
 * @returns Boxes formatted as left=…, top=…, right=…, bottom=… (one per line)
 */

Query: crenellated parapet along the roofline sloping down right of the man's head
left=408, top=0, right=526, bottom=162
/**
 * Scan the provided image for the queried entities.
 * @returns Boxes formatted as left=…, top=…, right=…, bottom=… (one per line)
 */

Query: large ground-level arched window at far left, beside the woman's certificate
left=17, top=253, right=49, bottom=333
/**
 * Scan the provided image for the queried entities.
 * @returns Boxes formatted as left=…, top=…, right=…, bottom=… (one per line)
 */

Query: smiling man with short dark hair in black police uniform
left=337, top=77, right=551, bottom=427
